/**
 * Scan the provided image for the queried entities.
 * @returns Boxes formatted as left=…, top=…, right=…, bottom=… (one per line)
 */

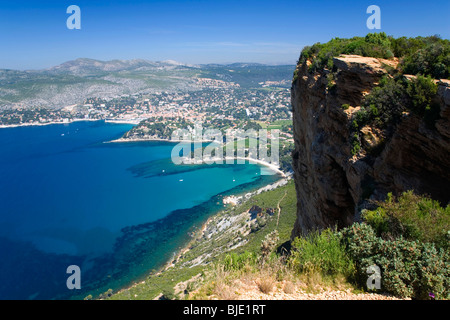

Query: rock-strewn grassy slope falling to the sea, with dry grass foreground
left=103, top=180, right=412, bottom=300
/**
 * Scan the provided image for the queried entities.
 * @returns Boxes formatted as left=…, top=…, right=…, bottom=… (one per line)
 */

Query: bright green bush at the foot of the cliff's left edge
left=288, top=229, right=354, bottom=278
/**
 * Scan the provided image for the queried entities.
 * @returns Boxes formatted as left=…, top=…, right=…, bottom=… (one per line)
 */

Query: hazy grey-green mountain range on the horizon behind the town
left=0, top=58, right=294, bottom=109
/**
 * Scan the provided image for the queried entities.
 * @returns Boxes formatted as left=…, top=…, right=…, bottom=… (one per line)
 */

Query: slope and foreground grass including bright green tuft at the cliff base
left=110, top=180, right=366, bottom=300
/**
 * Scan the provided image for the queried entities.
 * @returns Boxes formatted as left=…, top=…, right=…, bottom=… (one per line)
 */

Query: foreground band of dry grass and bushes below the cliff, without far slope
left=193, top=188, right=450, bottom=299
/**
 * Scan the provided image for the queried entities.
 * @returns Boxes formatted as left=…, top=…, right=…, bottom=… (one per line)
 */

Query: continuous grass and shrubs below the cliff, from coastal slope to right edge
left=104, top=174, right=450, bottom=300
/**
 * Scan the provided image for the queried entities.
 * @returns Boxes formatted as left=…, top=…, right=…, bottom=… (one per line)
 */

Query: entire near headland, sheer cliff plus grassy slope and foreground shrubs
left=96, top=34, right=450, bottom=300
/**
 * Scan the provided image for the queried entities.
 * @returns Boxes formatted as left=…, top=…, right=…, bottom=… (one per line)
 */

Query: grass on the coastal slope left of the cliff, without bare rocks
left=107, top=180, right=296, bottom=300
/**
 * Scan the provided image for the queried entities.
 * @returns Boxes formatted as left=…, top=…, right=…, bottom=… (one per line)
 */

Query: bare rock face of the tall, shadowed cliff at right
left=291, top=56, right=450, bottom=237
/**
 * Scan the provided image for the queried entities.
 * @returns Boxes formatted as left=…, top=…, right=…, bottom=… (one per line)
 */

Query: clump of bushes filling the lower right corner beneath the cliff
left=340, top=191, right=450, bottom=299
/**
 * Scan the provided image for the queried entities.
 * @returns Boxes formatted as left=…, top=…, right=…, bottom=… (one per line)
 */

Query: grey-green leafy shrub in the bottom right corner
left=340, top=223, right=450, bottom=299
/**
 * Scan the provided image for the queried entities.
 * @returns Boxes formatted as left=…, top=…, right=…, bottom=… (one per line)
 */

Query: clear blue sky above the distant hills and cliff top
left=0, top=0, right=450, bottom=69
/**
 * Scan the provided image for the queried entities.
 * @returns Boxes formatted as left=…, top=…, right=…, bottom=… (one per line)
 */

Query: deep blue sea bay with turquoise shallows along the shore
left=0, top=121, right=279, bottom=299
